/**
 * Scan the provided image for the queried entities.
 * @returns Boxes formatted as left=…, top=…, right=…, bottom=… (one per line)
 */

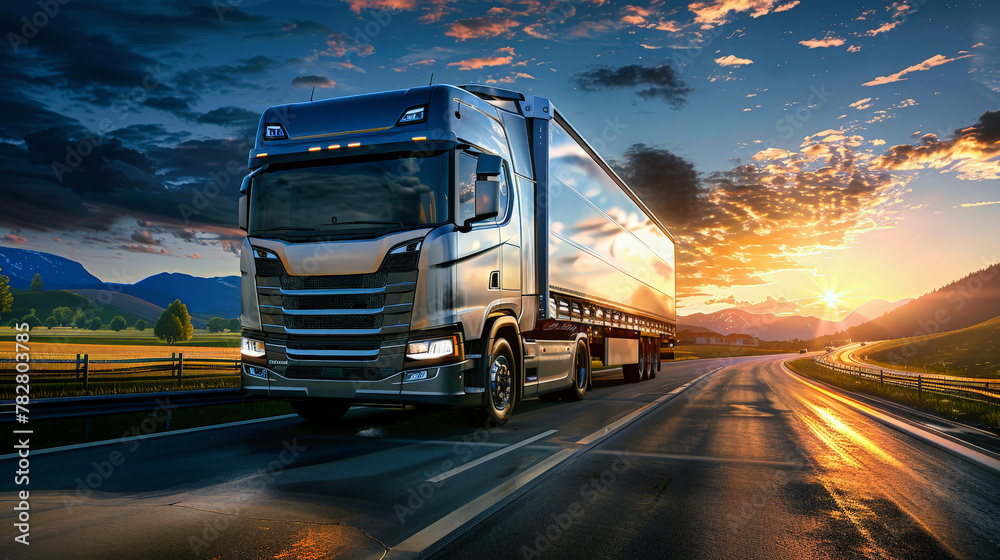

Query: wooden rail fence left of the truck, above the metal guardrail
left=0, top=353, right=240, bottom=390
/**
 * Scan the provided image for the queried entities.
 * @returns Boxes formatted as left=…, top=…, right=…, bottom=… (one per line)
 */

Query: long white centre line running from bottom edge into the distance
left=391, top=365, right=728, bottom=557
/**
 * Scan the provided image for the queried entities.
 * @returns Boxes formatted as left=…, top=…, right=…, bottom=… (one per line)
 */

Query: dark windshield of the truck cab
left=249, top=151, right=451, bottom=239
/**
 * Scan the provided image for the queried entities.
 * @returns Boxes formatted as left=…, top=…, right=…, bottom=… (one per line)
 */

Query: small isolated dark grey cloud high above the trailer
left=573, top=64, right=694, bottom=109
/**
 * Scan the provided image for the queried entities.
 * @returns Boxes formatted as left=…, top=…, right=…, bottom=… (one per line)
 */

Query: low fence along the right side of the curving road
left=813, top=353, right=1000, bottom=404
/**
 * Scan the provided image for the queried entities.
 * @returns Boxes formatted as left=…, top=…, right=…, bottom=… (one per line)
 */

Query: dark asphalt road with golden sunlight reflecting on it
left=0, top=356, right=1000, bottom=559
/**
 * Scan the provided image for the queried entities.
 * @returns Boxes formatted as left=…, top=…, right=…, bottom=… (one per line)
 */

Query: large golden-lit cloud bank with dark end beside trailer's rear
left=614, top=129, right=908, bottom=300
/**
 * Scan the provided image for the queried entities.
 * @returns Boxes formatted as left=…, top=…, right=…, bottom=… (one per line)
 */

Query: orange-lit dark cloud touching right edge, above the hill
left=875, top=111, right=1000, bottom=181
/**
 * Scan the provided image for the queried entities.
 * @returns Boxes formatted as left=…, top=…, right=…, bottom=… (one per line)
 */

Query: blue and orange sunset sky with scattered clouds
left=0, top=0, right=1000, bottom=320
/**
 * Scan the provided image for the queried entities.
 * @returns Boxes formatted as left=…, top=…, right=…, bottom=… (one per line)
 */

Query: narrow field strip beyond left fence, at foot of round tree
left=0, top=326, right=240, bottom=348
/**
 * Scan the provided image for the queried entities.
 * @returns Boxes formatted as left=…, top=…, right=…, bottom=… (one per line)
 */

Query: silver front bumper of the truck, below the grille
left=240, top=359, right=483, bottom=407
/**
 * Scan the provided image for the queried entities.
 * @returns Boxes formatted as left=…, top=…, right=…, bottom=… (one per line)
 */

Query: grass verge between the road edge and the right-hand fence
left=787, top=358, right=1000, bottom=432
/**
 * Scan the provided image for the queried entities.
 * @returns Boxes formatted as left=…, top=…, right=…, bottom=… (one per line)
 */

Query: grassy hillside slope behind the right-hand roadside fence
left=859, top=317, right=1000, bottom=378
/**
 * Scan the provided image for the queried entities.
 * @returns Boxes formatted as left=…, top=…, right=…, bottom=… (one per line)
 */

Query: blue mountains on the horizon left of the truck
left=0, top=247, right=240, bottom=319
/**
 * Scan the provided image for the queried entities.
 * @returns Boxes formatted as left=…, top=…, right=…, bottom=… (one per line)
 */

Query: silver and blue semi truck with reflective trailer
left=239, top=85, right=676, bottom=425
